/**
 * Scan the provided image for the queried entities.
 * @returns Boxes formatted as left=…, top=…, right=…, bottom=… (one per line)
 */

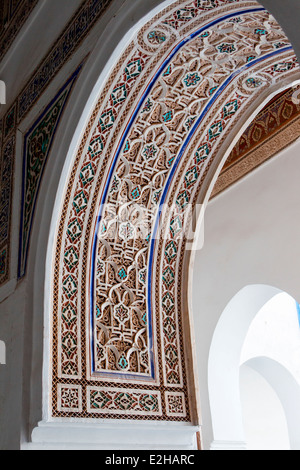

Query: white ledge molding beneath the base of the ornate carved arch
left=22, top=420, right=199, bottom=450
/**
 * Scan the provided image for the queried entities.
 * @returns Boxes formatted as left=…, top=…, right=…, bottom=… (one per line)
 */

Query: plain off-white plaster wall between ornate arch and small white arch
left=191, top=141, right=300, bottom=449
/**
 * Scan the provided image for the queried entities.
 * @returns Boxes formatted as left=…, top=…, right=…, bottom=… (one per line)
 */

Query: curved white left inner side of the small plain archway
left=208, top=285, right=280, bottom=450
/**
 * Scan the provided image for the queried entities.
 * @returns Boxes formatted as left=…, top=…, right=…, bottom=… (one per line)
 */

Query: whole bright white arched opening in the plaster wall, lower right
left=208, top=285, right=300, bottom=450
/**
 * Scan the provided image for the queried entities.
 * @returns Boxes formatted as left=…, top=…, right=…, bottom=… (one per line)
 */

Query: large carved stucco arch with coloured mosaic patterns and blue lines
left=50, top=0, right=299, bottom=423
